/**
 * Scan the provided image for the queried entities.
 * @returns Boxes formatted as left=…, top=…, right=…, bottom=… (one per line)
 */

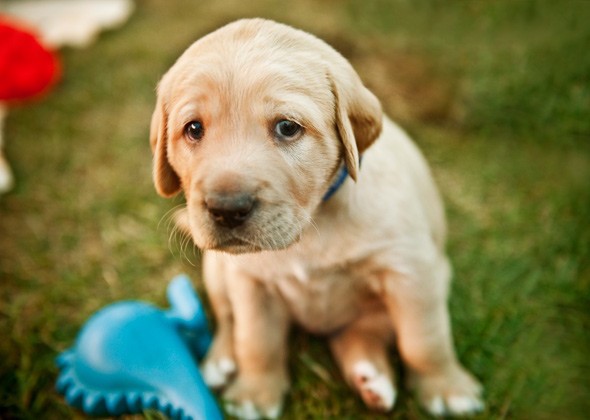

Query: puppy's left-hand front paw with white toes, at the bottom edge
left=223, top=373, right=289, bottom=420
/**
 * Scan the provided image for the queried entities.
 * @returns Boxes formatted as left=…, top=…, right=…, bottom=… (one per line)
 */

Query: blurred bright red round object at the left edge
left=0, top=16, right=61, bottom=102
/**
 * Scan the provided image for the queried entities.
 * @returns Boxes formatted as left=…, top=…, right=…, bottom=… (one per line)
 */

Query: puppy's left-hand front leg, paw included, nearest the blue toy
left=223, top=274, right=289, bottom=419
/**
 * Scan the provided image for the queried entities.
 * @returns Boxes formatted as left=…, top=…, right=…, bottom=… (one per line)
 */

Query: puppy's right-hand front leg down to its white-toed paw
left=383, top=255, right=483, bottom=415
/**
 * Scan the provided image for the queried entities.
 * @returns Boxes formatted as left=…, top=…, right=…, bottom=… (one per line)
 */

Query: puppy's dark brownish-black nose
left=205, top=193, right=256, bottom=229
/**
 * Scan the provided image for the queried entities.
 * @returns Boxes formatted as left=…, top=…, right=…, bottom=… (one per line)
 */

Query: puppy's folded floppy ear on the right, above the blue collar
left=329, top=65, right=383, bottom=180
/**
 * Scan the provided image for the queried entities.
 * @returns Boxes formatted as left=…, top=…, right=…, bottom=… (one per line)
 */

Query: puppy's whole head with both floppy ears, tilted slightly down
left=150, top=19, right=382, bottom=253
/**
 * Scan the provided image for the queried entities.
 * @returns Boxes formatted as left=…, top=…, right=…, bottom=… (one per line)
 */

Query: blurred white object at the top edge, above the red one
left=3, top=0, right=134, bottom=48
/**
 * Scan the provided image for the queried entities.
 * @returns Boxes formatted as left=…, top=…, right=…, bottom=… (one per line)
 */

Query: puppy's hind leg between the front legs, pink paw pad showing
left=330, top=313, right=397, bottom=412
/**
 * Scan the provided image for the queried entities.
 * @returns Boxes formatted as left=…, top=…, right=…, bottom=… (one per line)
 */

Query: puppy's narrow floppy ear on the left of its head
left=150, top=82, right=181, bottom=197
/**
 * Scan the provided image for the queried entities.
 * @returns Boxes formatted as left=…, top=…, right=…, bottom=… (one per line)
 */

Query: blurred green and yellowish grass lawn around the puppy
left=0, top=0, right=590, bottom=419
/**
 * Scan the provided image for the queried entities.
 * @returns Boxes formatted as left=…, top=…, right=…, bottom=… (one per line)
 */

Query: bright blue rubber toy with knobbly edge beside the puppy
left=56, top=275, right=223, bottom=420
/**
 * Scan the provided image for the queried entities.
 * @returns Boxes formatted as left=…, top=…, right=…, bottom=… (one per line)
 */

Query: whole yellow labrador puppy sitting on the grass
left=151, top=19, right=483, bottom=418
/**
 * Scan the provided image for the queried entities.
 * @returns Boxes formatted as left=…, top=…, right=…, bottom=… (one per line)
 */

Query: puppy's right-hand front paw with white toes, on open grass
left=410, top=365, right=484, bottom=416
